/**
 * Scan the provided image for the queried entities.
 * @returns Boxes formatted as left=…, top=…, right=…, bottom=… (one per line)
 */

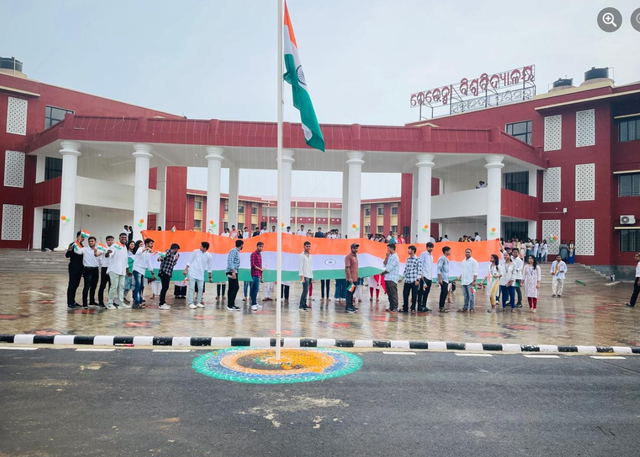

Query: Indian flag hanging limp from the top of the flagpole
left=284, top=2, right=324, bottom=152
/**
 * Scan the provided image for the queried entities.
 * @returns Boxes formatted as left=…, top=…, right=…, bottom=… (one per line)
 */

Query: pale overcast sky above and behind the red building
left=0, top=0, right=640, bottom=198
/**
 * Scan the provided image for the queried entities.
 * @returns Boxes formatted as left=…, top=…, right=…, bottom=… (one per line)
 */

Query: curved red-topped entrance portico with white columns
left=23, top=115, right=545, bottom=248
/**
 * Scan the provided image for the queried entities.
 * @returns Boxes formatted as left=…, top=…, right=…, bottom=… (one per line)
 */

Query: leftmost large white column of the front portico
left=57, top=140, right=80, bottom=251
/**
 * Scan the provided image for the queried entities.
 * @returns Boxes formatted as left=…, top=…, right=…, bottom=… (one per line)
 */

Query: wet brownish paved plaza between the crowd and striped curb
left=0, top=266, right=640, bottom=346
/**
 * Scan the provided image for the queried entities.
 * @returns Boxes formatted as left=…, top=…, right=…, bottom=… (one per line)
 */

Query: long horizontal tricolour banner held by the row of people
left=142, top=231, right=500, bottom=282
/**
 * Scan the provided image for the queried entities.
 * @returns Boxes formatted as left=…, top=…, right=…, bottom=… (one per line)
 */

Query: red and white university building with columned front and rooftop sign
left=0, top=59, right=640, bottom=277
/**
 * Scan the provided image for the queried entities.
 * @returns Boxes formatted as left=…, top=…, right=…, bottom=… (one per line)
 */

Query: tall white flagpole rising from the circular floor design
left=276, top=0, right=289, bottom=360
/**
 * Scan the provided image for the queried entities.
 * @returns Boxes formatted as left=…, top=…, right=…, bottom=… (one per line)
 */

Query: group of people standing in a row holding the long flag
left=66, top=226, right=640, bottom=313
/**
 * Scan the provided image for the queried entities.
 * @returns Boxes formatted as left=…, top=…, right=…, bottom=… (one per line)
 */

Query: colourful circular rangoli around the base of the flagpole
left=192, top=348, right=362, bottom=384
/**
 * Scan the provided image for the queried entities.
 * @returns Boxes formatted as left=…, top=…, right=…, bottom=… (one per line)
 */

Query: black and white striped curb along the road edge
left=0, top=334, right=640, bottom=354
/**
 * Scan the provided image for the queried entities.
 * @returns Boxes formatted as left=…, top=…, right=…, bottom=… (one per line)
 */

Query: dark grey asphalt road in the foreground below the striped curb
left=0, top=347, right=640, bottom=457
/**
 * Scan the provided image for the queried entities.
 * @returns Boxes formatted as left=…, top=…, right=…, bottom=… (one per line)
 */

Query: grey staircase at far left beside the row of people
left=0, top=249, right=69, bottom=274
